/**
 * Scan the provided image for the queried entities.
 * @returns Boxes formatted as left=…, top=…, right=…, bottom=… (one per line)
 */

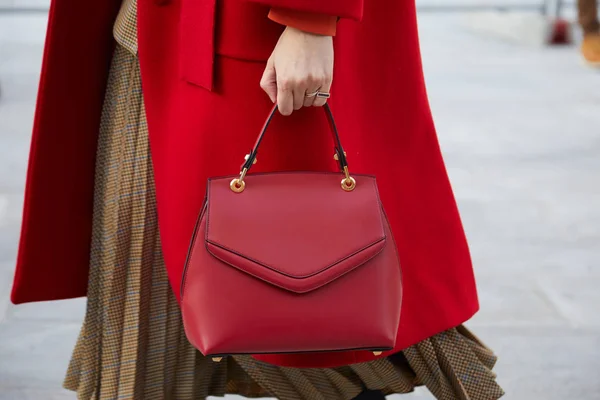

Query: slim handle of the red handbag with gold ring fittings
left=229, top=103, right=356, bottom=193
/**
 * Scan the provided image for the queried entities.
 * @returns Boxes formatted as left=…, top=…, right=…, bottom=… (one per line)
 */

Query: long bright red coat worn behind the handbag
left=12, top=0, right=478, bottom=366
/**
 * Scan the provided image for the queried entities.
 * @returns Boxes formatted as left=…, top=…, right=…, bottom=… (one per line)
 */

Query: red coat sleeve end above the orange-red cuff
left=243, top=0, right=364, bottom=21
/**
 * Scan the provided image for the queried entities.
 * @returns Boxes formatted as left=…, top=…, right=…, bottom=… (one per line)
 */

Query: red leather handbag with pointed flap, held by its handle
left=181, top=106, right=402, bottom=361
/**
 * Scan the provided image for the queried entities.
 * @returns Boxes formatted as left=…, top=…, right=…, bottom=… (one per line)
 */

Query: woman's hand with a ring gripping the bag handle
left=260, top=27, right=333, bottom=115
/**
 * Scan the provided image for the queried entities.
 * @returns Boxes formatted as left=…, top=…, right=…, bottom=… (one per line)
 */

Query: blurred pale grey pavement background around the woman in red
left=0, top=0, right=600, bottom=400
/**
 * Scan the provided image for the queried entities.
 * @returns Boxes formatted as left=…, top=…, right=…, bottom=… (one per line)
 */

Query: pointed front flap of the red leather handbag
left=205, top=172, right=386, bottom=293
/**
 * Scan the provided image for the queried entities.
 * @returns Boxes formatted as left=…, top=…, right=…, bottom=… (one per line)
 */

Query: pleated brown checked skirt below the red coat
left=64, top=0, right=503, bottom=400
